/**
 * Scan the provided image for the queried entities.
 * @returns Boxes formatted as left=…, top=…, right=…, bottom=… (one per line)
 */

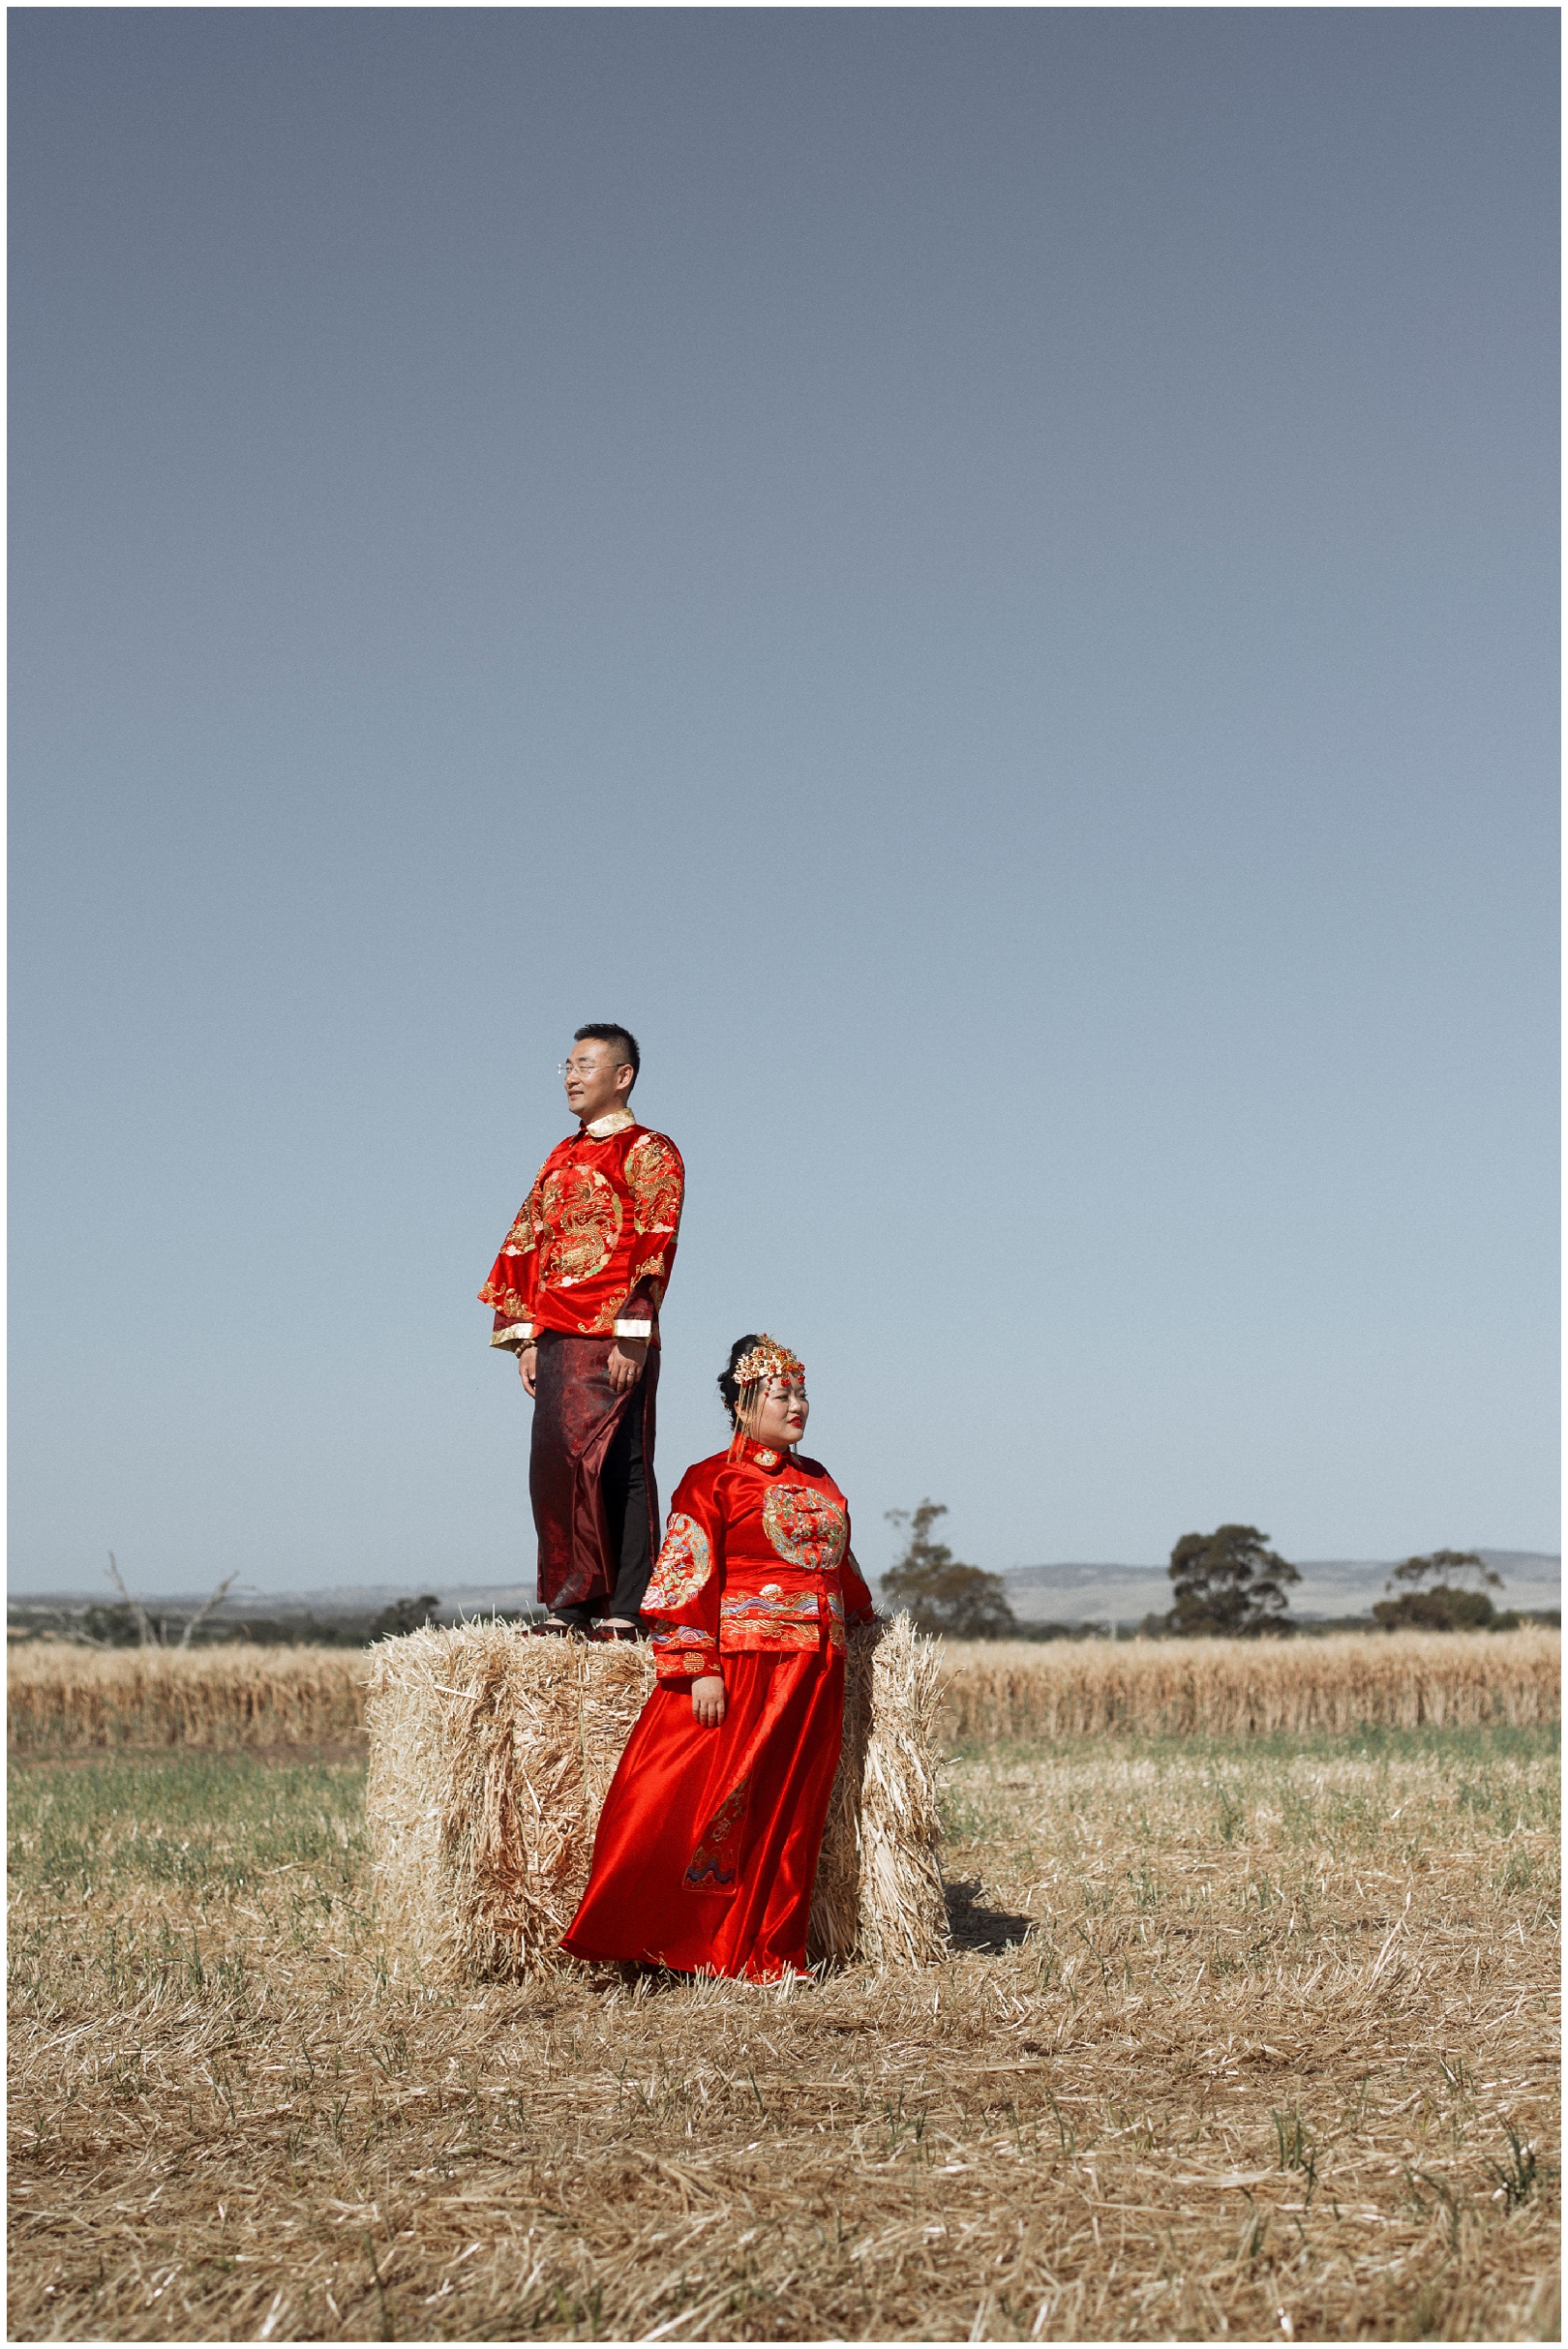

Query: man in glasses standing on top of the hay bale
left=479, top=1022, right=686, bottom=1640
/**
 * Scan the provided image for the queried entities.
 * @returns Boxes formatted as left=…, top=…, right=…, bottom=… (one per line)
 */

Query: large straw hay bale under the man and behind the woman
left=367, top=1618, right=945, bottom=1978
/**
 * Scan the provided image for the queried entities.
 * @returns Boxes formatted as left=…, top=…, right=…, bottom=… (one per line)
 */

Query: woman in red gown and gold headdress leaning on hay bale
left=561, top=1332, right=877, bottom=1982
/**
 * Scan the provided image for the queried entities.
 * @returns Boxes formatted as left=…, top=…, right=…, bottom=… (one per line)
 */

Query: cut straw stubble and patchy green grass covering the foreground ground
left=10, top=1727, right=1558, bottom=2339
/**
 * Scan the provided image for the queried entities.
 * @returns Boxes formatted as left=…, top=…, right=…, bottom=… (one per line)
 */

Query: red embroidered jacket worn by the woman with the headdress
left=642, top=1442, right=877, bottom=1679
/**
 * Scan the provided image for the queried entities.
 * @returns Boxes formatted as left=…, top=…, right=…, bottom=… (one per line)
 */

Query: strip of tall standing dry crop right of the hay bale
left=945, top=1630, right=1561, bottom=1743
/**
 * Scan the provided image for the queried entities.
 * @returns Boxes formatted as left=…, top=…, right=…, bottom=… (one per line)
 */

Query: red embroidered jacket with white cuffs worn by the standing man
left=479, top=1109, right=686, bottom=1353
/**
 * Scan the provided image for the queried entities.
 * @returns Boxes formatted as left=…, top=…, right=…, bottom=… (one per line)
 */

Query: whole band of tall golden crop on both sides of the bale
left=10, top=1630, right=1561, bottom=1753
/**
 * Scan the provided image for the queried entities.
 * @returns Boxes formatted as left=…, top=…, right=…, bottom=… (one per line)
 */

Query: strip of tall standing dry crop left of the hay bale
left=5, top=1640, right=367, bottom=1755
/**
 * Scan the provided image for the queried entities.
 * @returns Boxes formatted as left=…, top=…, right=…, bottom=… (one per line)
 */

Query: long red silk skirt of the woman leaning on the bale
left=561, top=1649, right=844, bottom=1982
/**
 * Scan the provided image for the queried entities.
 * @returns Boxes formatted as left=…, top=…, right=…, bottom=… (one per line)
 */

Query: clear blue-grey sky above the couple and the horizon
left=10, top=7, right=1558, bottom=1590
